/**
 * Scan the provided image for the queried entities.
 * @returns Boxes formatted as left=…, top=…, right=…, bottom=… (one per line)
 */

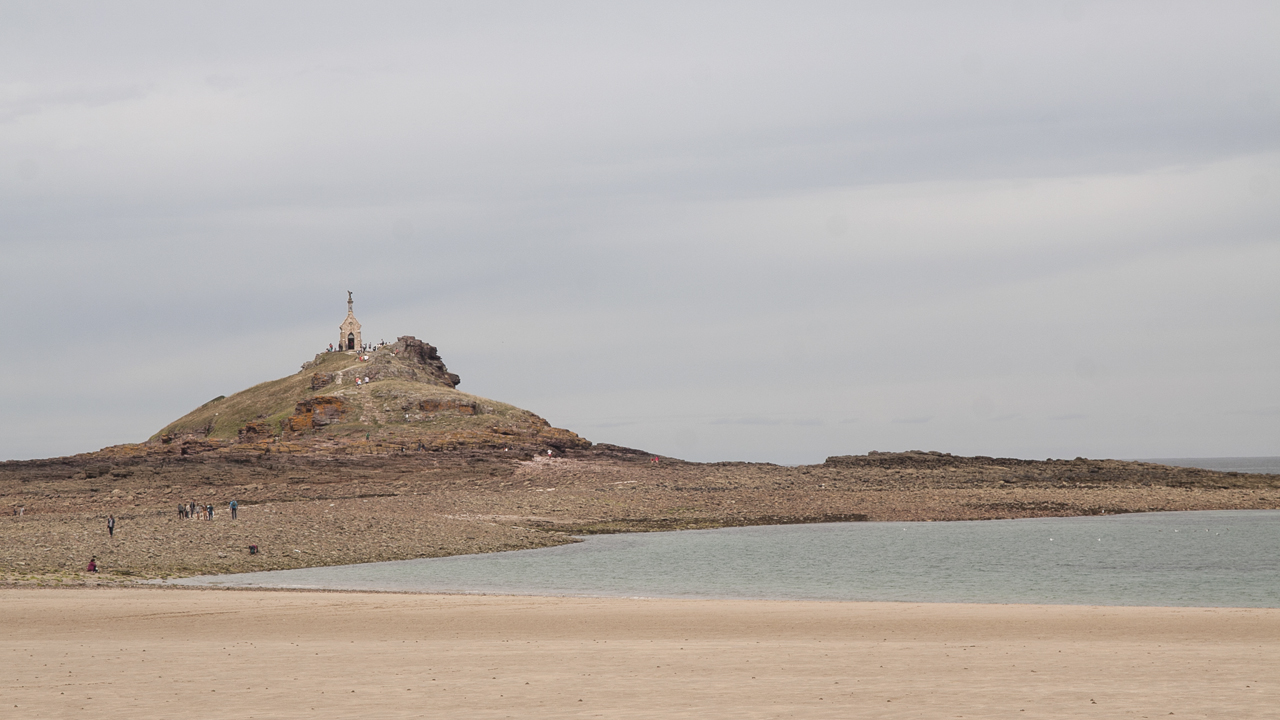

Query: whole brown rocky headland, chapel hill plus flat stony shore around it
left=0, top=337, right=1280, bottom=584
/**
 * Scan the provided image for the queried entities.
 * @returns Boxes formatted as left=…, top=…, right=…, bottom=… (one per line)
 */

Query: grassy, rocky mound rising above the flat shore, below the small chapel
left=147, top=336, right=591, bottom=455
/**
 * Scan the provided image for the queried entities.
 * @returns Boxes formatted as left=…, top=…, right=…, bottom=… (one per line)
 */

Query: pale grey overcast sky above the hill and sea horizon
left=0, top=0, right=1280, bottom=464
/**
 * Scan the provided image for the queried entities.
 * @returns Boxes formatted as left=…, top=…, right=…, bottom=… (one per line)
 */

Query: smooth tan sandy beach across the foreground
left=0, top=588, right=1280, bottom=719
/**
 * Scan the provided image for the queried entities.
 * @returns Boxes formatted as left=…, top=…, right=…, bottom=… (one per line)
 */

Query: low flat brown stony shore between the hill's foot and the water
left=0, top=445, right=1280, bottom=585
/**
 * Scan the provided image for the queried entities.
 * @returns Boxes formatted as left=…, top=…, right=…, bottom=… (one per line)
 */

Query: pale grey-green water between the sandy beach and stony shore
left=177, top=510, right=1280, bottom=607
